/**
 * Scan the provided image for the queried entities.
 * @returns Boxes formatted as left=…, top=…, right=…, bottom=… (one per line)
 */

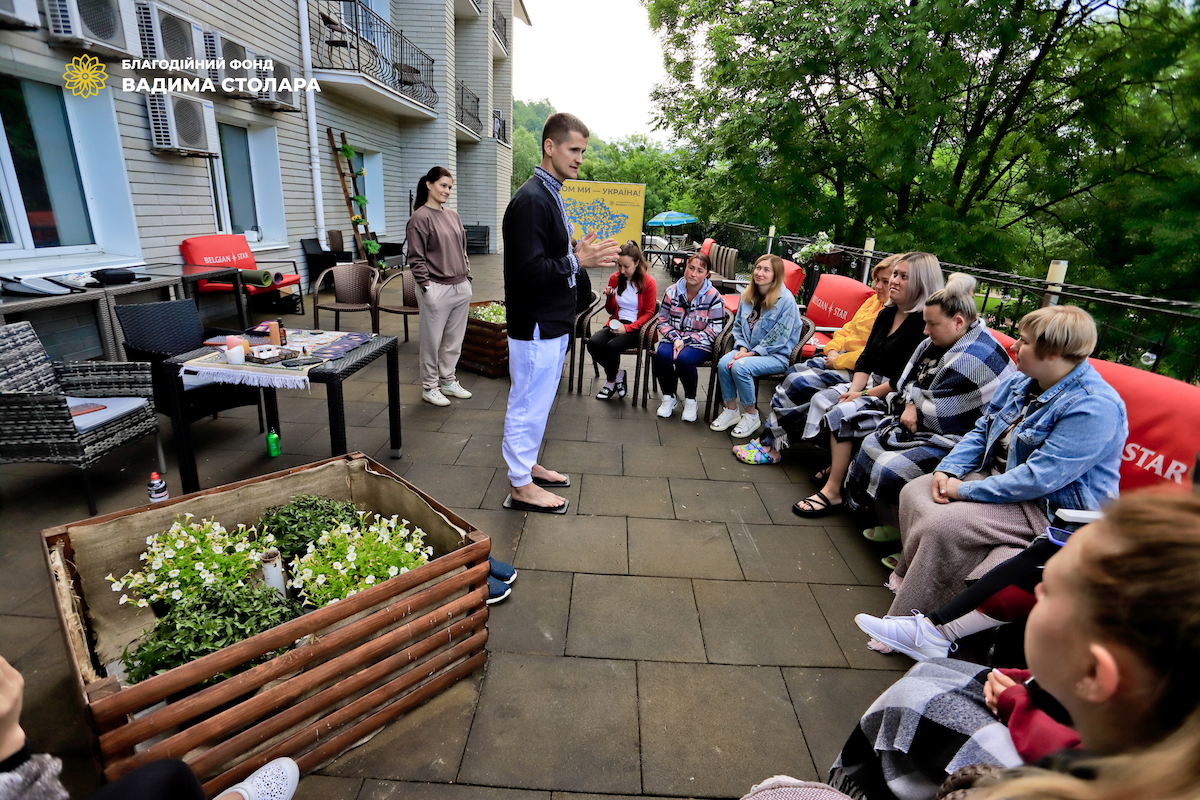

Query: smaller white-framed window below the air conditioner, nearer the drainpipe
left=209, top=122, right=288, bottom=245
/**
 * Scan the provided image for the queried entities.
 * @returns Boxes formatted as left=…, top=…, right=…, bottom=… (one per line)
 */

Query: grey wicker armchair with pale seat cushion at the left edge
left=0, top=323, right=167, bottom=516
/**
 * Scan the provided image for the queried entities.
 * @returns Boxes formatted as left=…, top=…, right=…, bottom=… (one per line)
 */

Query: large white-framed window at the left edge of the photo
left=0, top=74, right=98, bottom=255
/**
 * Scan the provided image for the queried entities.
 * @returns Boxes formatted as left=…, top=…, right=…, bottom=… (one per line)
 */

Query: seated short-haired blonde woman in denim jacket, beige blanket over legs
left=888, top=306, right=1129, bottom=614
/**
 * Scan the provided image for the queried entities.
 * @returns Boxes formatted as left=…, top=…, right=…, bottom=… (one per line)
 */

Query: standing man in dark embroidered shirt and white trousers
left=503, top=114, right=618, bottom=513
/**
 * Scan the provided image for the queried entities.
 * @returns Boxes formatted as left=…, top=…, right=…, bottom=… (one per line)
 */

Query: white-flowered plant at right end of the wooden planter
left=288, top=512, right=433, bottom=607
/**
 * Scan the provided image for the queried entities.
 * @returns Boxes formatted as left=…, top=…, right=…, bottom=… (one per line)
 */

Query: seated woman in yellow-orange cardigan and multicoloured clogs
left=733, top=255, right=900, bottom=464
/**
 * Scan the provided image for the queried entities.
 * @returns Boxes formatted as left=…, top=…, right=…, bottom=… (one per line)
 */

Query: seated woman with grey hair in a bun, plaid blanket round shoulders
left=845, top=272, right=1016, bottom=551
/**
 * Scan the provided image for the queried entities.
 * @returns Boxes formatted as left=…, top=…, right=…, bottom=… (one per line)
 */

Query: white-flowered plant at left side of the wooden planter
left=106, top=513, right=266, bottom=608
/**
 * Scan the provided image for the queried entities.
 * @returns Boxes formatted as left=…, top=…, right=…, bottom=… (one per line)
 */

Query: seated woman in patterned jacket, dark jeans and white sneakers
left=654, top=253, right=725, bottom=422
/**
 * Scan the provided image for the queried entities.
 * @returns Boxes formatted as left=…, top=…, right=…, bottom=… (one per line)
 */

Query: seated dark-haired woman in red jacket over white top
left=588, top=240, right=659, bottom=399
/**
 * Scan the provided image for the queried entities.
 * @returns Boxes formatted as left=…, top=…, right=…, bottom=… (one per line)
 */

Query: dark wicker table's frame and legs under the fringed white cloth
left=166, top=335, right=401, bottom=493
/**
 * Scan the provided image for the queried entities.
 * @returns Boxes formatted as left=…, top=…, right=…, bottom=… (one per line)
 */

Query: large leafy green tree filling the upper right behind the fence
left=646, top=0, right=1200, bottom=293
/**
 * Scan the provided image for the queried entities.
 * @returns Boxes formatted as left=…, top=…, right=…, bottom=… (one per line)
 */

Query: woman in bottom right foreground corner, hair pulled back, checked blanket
left=829, top=492, right=1200, bottom=800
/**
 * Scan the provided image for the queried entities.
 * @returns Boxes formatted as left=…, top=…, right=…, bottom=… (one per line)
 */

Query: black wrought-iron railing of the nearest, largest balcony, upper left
left=308, top=0, right=438, bottom=106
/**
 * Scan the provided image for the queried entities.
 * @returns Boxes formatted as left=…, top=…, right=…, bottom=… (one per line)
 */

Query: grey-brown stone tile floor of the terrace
left=0, top=255, right=908, bottom=800
